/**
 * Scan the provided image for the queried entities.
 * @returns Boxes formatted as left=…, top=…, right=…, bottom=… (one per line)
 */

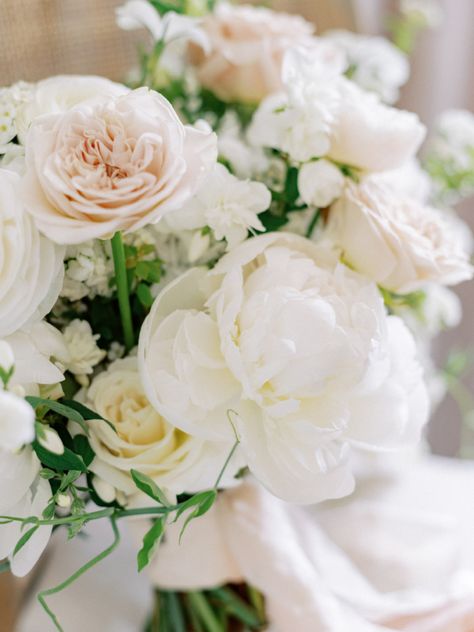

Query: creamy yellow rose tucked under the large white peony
left=81, top=357, right=241, bottom=496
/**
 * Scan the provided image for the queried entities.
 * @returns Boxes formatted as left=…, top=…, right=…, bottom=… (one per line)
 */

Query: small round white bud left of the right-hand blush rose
left=298, top=159, right=344, bottom=208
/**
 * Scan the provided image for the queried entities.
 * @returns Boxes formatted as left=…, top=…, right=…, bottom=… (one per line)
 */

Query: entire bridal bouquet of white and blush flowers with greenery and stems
left=0, top=0, right=474, bottom=632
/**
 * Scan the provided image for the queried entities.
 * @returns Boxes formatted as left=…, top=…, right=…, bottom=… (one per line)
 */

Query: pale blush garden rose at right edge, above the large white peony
left=328, top=178, right=473, bottom=294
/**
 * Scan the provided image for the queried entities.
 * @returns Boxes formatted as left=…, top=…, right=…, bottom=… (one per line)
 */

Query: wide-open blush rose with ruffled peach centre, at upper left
left=23, top=88, right=217, bottom=244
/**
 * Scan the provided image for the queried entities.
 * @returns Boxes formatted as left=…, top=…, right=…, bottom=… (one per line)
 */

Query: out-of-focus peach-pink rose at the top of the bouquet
left=190, top=3, right=314, bottom=103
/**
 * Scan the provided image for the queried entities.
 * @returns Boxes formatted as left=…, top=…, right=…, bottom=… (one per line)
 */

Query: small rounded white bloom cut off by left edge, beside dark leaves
left=0, top=389, right=35, bottom=452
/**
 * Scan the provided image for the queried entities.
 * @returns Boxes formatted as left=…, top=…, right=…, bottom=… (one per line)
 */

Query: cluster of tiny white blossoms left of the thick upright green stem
left=60, top=239, right=114, bottom=301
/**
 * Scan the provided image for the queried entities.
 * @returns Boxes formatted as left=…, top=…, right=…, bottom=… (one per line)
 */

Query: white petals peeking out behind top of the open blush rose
left=16, top=75, right=129, bottom=145
